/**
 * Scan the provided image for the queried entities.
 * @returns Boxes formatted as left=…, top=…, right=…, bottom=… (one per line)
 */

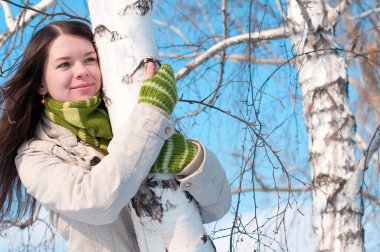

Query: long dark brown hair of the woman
left=0, top=21, right=93, bottom=222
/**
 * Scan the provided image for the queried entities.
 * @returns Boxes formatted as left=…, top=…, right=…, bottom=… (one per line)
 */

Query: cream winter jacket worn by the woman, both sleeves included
left=15, top=104, right=231, bottom=252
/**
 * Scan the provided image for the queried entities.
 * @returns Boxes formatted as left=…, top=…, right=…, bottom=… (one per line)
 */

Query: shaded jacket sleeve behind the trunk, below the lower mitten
left=178, top=141, right=231, bottom=223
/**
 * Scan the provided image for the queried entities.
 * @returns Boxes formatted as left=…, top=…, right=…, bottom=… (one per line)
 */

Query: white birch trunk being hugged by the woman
left=88, top=0, right=213, bottom=252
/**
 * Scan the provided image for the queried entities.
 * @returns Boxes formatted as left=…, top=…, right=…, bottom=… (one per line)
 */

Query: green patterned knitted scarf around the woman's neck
left=44, top=93, right=112, bottom=154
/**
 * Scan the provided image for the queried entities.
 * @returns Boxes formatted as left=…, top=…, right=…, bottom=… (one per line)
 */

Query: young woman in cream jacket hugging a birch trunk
left=0, top=21, right=231, bottom=251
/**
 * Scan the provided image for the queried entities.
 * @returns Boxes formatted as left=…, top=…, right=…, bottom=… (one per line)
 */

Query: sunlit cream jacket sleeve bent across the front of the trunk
left=15, top=104, right=174, bottom=225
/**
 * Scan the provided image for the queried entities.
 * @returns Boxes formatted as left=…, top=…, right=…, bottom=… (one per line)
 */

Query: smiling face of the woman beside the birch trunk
left=39, top=34, right=102, bottom=102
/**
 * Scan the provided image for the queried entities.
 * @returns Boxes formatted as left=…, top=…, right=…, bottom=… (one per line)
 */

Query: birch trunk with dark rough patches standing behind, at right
left=288, top=0, right=364, bottom=252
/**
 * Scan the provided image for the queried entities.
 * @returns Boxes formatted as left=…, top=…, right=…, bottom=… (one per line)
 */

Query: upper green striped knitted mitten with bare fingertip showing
left=138, top=65, right=178, bottom=115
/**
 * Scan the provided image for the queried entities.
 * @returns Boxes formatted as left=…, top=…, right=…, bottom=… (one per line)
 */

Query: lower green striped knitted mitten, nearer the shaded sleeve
left=149, top=133, right=198, bottom=174
